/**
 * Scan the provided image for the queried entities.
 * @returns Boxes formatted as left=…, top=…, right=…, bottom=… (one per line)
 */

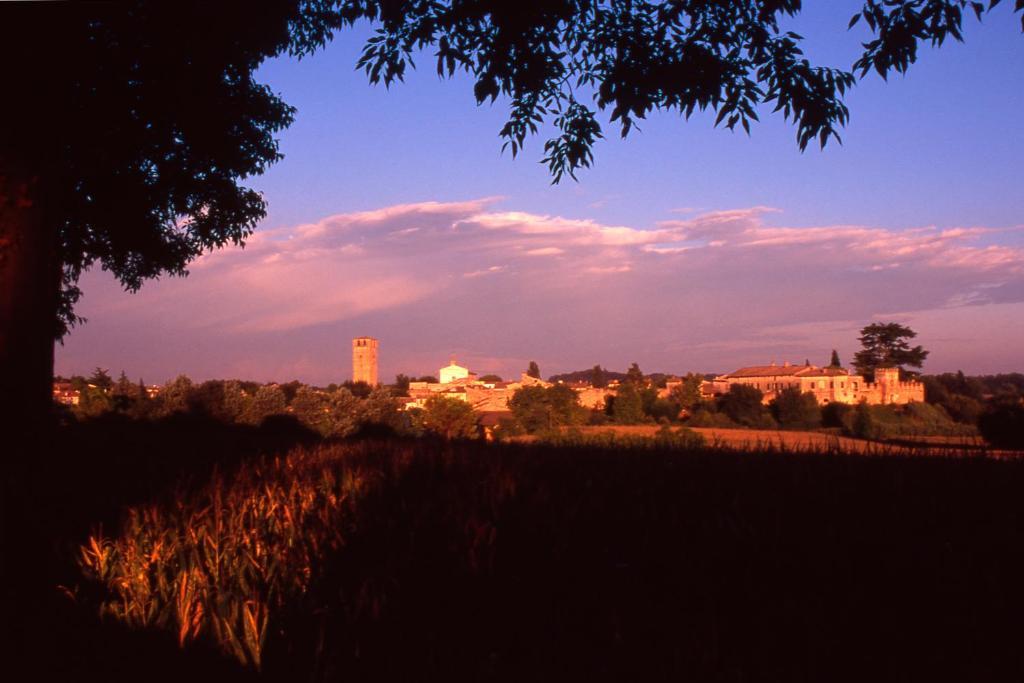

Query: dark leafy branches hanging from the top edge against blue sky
left=344, top=0, right=1024, bottom=182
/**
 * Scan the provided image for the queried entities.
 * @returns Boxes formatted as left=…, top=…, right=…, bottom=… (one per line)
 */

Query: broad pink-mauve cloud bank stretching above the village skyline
left=61, top=198, right=1024, bottom=383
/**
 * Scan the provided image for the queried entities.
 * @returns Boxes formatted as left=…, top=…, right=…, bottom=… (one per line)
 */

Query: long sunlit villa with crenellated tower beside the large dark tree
left=701, top=362, right=925, bottom=405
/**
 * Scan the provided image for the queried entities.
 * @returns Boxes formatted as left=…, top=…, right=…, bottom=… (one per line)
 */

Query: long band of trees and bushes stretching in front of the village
left=56, top=364, right=1024, bottom=449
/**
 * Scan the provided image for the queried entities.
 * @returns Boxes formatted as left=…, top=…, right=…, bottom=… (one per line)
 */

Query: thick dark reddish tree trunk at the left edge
left=0, top=157, right=61, bottom=432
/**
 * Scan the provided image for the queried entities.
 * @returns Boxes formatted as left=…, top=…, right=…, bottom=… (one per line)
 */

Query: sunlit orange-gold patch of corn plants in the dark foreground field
left=80, top=449, right=385, bottom=669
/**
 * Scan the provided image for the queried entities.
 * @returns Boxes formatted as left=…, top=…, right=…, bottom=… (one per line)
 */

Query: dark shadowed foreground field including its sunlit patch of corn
left=5, top=418, right=1024, bottom=681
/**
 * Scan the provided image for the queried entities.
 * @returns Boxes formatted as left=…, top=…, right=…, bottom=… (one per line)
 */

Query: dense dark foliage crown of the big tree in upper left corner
left=0, top=0, right=350, bottom=336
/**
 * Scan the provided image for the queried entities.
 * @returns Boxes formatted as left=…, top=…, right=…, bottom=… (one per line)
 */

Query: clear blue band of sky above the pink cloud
left=249, top=2, right=1024, bottom=232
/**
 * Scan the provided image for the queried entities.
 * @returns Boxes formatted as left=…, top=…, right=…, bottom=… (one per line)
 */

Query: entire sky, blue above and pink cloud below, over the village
left=56, top=0, right=1024, bottom=385
